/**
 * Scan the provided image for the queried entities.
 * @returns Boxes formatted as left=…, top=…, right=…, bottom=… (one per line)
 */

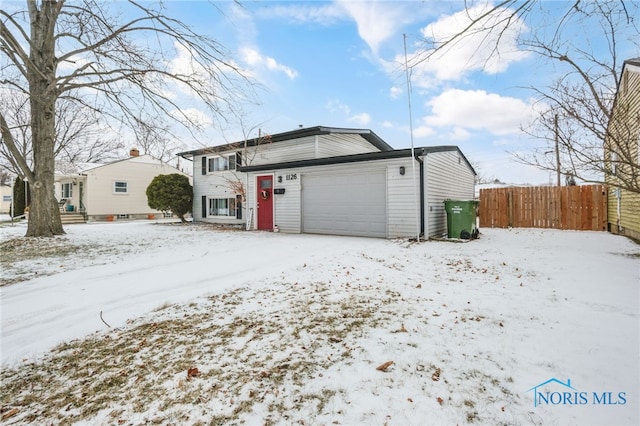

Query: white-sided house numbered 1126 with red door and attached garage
left=179, top=126, right=476, bottom=238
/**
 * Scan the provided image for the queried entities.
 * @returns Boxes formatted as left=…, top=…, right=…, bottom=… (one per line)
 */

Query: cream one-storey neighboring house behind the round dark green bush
left=55, top=149, right=191, bottom=221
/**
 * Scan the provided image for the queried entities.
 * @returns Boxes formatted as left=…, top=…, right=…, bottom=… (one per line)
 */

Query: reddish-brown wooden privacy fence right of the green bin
left=479, top=185, right=607, bottom=231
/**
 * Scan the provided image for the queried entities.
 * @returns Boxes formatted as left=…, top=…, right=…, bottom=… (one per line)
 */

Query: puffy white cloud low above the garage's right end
left=424, top=89, right=533, bottom=136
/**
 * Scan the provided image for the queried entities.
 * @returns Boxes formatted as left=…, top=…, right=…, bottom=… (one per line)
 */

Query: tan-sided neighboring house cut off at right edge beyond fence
left=605, top=58, right=640, bottom=240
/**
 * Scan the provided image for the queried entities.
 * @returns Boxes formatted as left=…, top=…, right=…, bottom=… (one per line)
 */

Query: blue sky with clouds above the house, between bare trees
left=150, top=1, right=638, bottom=184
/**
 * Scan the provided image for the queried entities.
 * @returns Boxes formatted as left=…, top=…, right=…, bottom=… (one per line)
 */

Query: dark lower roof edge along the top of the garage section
left=239, top=145, right=477, bottom=175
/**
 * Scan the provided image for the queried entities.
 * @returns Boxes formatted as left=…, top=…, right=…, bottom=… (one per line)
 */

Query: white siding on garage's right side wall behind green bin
left=424, top=151, right=475, bottom=237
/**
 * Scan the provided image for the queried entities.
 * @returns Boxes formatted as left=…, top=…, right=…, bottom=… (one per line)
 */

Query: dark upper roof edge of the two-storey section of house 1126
left=177, top=126, right=393, bottom=158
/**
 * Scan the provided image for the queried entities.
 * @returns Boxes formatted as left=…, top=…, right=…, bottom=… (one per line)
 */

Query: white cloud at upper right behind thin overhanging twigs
left=396, top=4, right=529, bottom=87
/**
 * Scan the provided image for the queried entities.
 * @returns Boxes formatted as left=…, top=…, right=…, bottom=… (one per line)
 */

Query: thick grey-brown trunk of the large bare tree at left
left=27, top=2, right=64, bottom=237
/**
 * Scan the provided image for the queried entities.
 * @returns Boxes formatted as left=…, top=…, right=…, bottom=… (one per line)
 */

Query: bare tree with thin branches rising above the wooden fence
left=414, top=0, right=640, bottom=192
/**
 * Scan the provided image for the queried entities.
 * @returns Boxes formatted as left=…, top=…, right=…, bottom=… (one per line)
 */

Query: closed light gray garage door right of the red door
left=302, top=172, right=387, bottom=238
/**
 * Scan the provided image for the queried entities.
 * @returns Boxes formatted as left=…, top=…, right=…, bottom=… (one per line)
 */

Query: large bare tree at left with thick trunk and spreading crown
left=0, top=0, right=251, bottom=236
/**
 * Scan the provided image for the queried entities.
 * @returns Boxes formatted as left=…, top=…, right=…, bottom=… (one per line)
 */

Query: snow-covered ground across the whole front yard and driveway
left=0, top=222, right=640, bottom=425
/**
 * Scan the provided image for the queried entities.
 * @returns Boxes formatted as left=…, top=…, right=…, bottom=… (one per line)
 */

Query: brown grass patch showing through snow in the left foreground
left=0, top=282, right=408, bottom=424
